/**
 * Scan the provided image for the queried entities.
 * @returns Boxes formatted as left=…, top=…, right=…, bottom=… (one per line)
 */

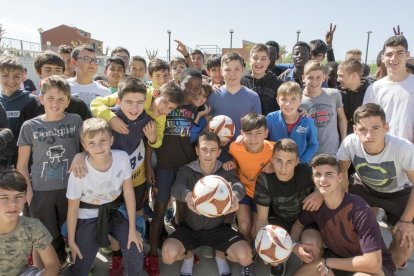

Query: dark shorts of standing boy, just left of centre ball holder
left=155, top=168, right=177, bottom=203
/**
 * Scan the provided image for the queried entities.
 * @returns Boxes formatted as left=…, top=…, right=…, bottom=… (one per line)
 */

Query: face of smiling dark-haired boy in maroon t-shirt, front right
left=312, top=165, right=342, bottom=196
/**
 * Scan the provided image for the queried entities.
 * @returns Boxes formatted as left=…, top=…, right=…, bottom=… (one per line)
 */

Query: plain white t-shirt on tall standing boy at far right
left=364, top=74, right=414, bottom=143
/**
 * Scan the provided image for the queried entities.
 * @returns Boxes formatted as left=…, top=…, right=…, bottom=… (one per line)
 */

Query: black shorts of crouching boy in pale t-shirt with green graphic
left=349, top=177, right=411, bottom=226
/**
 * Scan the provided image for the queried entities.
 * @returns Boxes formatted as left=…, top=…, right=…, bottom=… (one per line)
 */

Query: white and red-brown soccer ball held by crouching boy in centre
left=193, top=175, right=233, bottom=218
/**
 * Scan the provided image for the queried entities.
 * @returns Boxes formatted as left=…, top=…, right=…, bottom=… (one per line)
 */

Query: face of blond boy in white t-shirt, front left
left=82, top=131, right=114, bottom=158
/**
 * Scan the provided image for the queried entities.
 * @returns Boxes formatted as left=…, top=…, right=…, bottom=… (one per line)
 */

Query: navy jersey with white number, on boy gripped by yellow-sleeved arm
left=112, top=108, right=151, bottom=187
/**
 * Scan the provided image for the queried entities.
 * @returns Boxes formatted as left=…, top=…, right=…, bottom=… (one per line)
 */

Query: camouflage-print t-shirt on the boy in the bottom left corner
left=0, top=216, right=53, bottom=275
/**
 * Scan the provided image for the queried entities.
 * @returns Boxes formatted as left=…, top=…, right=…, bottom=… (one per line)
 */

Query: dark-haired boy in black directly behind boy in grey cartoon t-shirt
left=22, top=51, right=92, bottom=121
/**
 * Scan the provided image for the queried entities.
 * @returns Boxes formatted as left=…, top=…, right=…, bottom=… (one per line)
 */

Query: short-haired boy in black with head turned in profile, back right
left=338, top=59, right=373, bottom=135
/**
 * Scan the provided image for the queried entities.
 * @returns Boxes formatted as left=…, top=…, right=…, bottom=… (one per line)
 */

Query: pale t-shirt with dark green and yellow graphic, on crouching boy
left=337, top=134, right=414, bottom=193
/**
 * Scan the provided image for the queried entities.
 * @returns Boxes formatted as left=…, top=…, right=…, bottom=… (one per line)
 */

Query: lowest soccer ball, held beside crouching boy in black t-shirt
left=254, top=225, right=293, bottom=265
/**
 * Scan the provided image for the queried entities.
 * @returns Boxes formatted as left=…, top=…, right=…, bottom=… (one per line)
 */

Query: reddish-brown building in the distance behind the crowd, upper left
left=39, top=25, right=103, bottom=55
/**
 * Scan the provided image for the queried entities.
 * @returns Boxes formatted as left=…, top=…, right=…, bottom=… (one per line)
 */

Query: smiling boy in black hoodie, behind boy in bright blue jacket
left=241, top=44, right=282, bottom=116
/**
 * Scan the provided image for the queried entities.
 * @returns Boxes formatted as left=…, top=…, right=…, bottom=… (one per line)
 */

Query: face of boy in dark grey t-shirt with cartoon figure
left=39, top=88, right=69, bottom=116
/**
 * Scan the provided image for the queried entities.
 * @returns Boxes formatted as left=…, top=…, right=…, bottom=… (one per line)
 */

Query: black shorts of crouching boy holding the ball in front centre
left=168, top=223, right=245, bottom=252
